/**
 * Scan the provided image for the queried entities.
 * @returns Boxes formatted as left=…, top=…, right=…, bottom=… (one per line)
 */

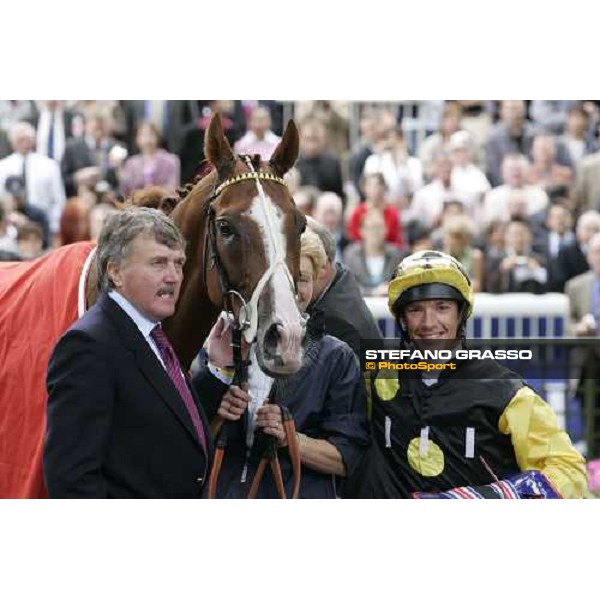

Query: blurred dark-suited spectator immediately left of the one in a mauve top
left=61, top=113, right=127, bottom=197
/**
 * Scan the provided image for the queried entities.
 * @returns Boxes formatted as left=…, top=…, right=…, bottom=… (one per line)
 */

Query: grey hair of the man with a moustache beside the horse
left=96, top=207, right=186, bottom=292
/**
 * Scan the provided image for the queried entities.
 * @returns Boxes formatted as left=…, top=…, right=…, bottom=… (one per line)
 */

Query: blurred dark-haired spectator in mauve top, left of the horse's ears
left=120, top=122, right=181, bottom=196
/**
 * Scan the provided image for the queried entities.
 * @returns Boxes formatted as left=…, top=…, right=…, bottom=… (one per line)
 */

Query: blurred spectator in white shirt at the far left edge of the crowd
left=0, top=122, right=65, bottom=235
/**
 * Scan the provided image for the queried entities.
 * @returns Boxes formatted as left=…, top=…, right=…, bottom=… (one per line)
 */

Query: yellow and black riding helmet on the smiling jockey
left=388, top=250, right=474, bottom=329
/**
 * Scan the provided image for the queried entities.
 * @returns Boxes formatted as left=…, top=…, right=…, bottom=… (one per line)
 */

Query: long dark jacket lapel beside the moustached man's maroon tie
left=98, top=294, right=208, bottom=446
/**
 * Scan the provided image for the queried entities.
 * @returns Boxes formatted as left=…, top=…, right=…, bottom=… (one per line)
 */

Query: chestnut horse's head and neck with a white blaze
left=165, top=115, right=306, bottom=376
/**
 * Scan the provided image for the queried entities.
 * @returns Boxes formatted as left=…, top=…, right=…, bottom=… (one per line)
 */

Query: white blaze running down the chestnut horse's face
left=248, top=194, right=302, bottom=361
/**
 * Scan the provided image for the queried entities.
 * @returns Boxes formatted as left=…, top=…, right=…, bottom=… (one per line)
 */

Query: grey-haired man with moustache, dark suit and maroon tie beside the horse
left=44, top=208, right=227, bottom=498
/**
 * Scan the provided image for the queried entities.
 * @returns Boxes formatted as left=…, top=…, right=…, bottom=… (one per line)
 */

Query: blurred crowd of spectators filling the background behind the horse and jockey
left=0, top=100, right=600, bottom=304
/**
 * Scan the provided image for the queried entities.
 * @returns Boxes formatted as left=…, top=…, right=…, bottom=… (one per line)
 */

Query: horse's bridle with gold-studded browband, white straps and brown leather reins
left=202, top=155, right=301, bottom=498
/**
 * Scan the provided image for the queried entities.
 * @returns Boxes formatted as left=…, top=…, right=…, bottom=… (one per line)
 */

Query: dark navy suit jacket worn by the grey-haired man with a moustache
left=44, top=295, right=226, bottom=498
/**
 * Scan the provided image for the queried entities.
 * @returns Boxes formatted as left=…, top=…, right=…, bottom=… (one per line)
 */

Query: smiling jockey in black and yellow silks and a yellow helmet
left=353, top=251, right=587, bottom=498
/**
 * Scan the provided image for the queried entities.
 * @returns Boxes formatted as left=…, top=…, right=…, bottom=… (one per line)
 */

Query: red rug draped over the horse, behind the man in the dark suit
left=0, top=242, right=95, bottom=498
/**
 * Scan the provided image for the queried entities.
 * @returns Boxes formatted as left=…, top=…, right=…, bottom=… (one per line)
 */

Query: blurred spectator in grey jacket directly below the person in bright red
left=344, top=208, right=401, bottom=296
